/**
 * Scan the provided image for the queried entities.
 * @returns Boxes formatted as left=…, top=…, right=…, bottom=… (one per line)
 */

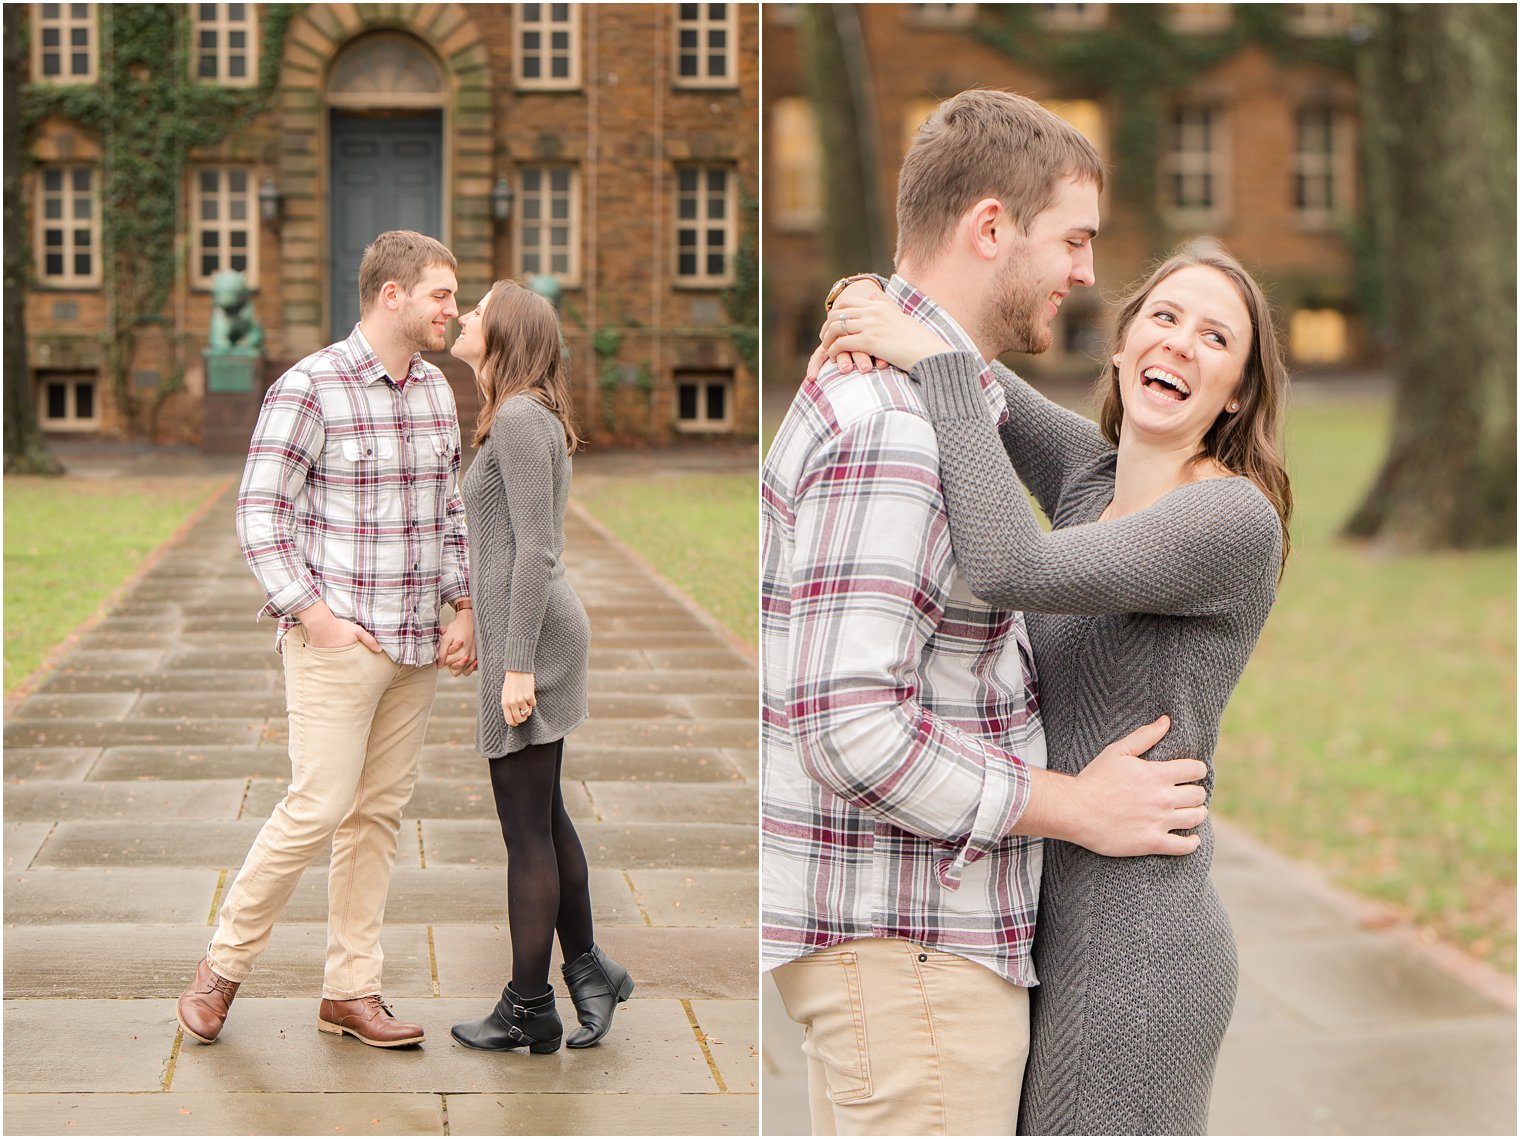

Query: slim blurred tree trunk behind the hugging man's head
left=801, top=5, right=892, bottom=277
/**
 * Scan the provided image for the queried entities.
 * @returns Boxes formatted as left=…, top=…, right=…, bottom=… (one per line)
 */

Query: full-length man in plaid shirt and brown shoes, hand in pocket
left=176, top=230, right=474, bottom=1048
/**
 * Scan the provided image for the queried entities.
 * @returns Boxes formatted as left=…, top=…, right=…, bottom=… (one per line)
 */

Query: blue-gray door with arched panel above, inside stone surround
left=327, top=32, right=448, bottom=341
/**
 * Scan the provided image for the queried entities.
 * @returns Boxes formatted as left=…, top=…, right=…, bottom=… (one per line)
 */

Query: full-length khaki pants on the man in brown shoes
left=207, top=625, right=438, bottom=1001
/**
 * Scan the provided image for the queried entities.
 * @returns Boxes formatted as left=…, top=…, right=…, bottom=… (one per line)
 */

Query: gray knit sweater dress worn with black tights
left=459, top=395, right=591, bottom=757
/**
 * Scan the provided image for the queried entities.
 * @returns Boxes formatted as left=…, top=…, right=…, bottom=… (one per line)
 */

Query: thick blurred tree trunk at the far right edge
left=1345, top=5, right=1515, bottom=549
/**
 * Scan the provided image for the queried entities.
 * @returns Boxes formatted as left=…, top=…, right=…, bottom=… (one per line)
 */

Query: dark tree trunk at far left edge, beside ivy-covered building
left=3, top=5, right=64, bottom=474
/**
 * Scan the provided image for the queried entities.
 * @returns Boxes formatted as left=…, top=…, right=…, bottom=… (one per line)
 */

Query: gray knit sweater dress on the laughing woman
left=914, top=353, right=1281, bottom=1134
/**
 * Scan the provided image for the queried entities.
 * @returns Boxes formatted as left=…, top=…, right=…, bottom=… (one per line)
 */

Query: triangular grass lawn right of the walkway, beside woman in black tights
left=575, top=471, right=760, bottom=646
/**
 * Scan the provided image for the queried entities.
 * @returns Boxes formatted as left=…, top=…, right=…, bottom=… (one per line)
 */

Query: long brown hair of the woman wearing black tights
left=474, top=281, right=581, bottom=455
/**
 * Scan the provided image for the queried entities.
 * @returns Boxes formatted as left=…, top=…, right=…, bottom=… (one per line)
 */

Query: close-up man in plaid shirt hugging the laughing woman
left=762, top=91, right=1204, bottom=1134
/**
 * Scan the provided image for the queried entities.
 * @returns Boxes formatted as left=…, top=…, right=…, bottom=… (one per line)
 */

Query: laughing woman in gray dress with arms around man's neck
left=827, top=242, right=1292, bottom=1134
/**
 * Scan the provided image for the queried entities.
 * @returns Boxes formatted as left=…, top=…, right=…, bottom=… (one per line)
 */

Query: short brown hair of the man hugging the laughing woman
left=897, top=90, right=1104, bottom=265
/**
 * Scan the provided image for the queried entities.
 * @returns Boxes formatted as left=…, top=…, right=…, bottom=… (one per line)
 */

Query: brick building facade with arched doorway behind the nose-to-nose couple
left=24, top=3, right=758, bottom=441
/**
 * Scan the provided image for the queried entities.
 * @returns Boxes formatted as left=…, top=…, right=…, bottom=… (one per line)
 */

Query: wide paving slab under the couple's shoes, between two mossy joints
left=171, top=998, right=717, bottom=1093
